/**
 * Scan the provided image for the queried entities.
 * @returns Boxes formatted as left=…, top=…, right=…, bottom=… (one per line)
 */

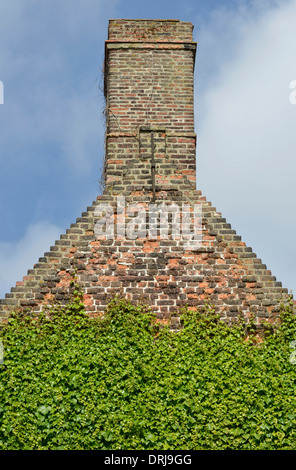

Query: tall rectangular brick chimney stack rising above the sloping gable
left=105, top=20, right=196, bottom=194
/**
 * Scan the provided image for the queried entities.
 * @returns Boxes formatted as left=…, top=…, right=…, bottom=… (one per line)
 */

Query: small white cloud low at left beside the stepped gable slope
left=0, top=222, right=63, bottom=298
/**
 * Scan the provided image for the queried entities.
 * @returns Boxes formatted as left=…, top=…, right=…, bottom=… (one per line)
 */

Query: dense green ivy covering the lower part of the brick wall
left=0, top=289, right=296, bottom=450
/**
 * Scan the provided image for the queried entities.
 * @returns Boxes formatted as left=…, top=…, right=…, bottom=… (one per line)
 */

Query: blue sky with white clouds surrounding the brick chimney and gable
left=0, top=0, right=296, bottom=297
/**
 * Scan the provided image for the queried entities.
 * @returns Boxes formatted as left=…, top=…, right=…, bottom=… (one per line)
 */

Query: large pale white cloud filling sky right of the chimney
left=196, top=0, right=296, bottom=291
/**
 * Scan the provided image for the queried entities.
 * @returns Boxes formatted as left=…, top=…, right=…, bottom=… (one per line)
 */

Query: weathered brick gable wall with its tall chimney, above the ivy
left=0, top=20, right=288, bottom=327
